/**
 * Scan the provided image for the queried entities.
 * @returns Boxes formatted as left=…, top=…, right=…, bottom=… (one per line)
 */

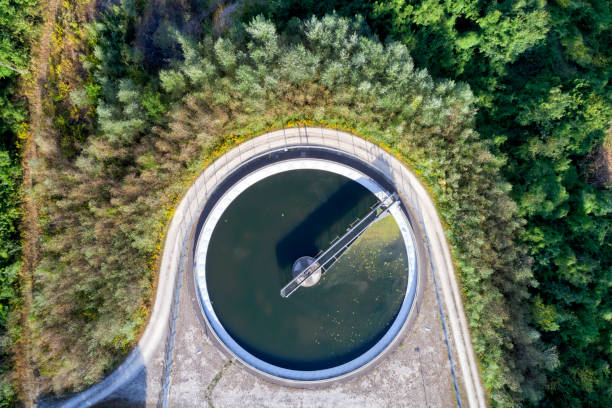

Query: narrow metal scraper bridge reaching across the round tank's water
left=280, top=194, right=399, bottom=298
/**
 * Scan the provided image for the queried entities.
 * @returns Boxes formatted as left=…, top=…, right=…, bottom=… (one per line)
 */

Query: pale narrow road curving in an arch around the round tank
left=63, top=128, right=486, bottom=407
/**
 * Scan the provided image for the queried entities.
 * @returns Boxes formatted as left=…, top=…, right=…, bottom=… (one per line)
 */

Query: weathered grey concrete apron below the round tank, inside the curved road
left=106, top=242, right=457, bottom=407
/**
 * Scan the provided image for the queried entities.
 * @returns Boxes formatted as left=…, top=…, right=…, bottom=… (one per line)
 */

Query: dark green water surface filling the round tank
left=206, top=170, right=407, bottom=370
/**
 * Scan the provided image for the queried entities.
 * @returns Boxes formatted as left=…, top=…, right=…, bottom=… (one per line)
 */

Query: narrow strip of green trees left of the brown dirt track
left=0, top=0, right=37, bottom=407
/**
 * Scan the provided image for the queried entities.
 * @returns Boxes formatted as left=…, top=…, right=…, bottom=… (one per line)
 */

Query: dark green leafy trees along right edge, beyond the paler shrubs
left=375, top=1, right=612, bottom=407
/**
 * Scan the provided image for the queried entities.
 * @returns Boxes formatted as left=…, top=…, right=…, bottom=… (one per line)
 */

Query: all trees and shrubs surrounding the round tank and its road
left=0, top=0, right=612, bottom=407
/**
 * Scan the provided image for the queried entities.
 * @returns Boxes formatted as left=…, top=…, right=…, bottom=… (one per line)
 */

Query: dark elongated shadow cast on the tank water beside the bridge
left=275, top=180, right=374, bottom=268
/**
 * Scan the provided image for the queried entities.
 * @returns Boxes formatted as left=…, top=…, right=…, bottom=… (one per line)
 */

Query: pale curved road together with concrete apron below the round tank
left=58, top=128, right=485, bottom=407
